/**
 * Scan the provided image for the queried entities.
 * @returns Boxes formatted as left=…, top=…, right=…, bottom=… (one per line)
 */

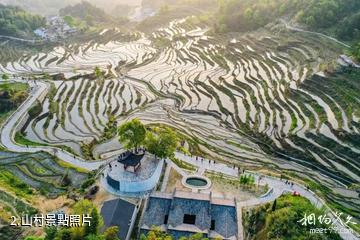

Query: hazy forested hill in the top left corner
left=0, top=4, right=46, bottom=37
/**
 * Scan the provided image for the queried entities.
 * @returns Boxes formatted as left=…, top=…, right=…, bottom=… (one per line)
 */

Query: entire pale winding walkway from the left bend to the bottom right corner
left=0, top=78, right=360, bottom=240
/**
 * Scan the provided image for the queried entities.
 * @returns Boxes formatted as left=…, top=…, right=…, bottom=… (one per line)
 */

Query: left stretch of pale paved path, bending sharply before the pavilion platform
left=0, top=79, right=107, bottom=171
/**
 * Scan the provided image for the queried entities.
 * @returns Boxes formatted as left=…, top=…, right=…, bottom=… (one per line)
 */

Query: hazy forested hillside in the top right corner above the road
left=216, top=0, right=360, bottom=41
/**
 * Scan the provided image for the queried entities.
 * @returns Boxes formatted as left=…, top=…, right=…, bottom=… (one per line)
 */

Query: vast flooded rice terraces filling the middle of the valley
left=0, top=17, right=360, bottom=215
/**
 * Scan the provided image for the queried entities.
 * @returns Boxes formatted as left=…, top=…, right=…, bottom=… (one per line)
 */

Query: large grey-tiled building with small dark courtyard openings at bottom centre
left=141, top=190, right=238, bottom=239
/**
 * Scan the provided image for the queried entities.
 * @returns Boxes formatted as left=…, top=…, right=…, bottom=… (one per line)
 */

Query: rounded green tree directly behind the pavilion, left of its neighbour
left=118, top=118, right=146, bottom=149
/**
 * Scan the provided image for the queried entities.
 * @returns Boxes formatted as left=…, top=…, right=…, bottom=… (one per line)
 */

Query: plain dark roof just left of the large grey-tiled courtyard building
left=101, top=198, right=136, bottom=239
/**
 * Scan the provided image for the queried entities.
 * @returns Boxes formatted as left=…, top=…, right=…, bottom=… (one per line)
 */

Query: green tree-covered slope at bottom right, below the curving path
left=244, top=195, right=341, bottom=240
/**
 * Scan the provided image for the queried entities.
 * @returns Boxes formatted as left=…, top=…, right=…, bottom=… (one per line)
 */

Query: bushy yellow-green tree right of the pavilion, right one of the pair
left=145, top=128, right=178, bottom=158
